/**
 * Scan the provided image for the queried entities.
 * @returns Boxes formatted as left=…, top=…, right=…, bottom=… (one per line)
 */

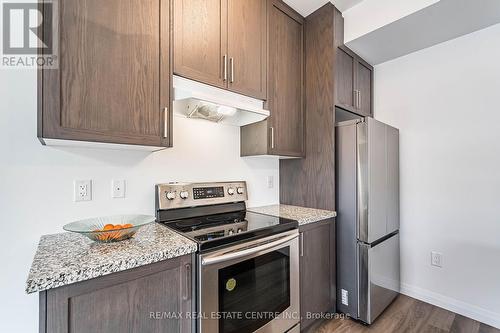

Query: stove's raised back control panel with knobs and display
left=156, top=181, right=248, bottom=210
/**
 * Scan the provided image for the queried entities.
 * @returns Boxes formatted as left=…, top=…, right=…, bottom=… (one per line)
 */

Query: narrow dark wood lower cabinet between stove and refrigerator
left=299, top=219, right=336, bottom=331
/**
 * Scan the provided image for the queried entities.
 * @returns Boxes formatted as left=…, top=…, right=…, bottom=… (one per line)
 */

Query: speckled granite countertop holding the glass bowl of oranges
left=26, top=223, right=197, bottom=293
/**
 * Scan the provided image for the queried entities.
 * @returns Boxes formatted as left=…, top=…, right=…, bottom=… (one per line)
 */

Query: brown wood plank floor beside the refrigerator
left=308, top=295, right=500, bottom=333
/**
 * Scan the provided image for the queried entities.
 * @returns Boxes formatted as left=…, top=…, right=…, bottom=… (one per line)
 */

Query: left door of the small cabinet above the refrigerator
left=335, top=48, right=356, bottom=110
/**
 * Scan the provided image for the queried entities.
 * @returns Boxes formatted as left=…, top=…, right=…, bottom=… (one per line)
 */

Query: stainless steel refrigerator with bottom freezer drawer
left=336, top=117, right=400, bottom=324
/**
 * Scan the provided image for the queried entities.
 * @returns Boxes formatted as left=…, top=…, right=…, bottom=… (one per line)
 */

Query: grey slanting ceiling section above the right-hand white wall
left=346, top=0, right=500, bottom=65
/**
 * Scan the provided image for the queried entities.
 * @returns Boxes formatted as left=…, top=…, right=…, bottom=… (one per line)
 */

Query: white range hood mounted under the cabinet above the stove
left=173, top=75, right=269, bottom=126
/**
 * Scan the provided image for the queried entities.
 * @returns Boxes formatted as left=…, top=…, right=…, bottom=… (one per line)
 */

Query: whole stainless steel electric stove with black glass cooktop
left=156, top=182, right=300, bottom=333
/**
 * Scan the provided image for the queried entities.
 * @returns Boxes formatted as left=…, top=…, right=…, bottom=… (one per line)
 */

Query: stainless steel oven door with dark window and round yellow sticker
left=198, top=230, right=300, bottom=333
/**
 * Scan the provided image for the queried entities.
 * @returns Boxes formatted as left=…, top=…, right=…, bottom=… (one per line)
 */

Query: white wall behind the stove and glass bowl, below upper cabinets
left=0, top=70, right=279, bottom=333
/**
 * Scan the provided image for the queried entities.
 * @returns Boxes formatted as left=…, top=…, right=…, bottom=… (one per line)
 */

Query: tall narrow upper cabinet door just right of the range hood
left=267, top=1, right=304, bottom=157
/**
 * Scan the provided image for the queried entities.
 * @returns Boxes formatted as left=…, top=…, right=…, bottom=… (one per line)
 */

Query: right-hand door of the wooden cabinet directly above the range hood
left=227, top=0, right=267, bottom=99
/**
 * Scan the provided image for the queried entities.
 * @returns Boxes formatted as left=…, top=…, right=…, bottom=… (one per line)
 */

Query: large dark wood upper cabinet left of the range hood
left=38, top=0, right=172, bottom=147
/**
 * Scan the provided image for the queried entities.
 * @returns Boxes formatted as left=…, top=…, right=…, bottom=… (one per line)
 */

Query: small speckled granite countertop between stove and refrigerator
left=247, top=205, right=337, bottom=225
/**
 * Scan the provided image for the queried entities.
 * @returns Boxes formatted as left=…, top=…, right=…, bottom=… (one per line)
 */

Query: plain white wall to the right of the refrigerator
left=375, top=25, right=500, bottom=328
